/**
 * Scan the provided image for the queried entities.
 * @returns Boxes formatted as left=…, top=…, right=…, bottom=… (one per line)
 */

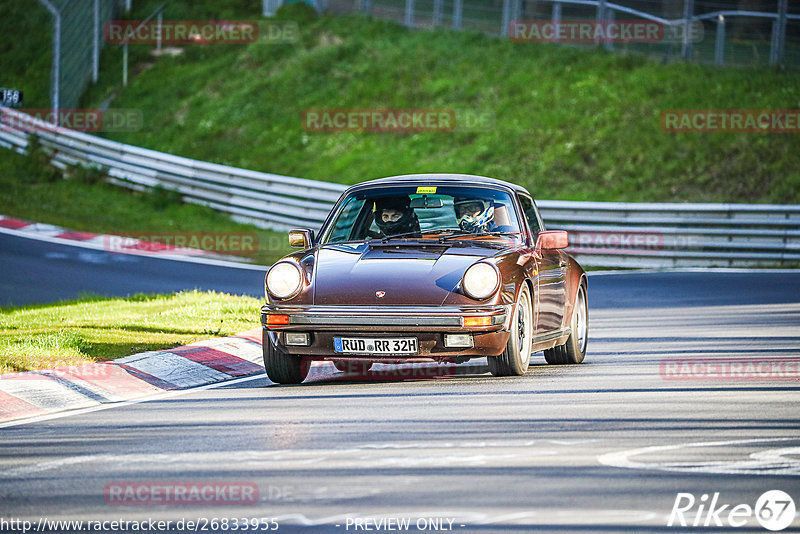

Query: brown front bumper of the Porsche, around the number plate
left=261, top=304, right=511, bottom=361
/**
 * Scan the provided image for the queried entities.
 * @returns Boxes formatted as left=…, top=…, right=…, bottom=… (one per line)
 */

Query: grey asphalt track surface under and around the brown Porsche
left=0, top=238, right=800, bottom=532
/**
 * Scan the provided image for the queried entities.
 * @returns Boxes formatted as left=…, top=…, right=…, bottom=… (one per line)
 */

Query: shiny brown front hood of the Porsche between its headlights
left=314, top=243, right=497, bottom=306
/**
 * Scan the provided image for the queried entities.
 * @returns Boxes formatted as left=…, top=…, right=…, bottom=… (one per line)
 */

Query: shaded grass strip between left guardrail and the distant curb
left=0, top=149, right=291, bottom=265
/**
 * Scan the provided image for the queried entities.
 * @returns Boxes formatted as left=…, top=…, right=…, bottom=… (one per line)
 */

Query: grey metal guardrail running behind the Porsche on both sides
left=0, top=108, right=800, bottom=267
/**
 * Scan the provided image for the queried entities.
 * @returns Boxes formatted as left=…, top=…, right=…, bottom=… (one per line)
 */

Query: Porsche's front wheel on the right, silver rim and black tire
left=486, top=283, right=533, bottom=376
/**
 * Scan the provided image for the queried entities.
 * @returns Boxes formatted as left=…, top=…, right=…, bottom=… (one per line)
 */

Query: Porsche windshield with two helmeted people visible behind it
left=321, top=186, right=520, bottom=244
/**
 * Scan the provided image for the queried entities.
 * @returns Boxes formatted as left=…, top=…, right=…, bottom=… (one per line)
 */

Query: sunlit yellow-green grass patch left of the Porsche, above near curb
left=0, top=291, right=261, bottom=374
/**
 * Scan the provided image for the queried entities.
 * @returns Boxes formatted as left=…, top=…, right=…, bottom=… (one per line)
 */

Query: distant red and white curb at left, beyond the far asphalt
left=0, top=215, right=248, bottom=262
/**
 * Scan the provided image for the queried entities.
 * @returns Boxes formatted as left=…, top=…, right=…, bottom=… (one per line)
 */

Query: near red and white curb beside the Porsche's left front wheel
left=0, top=328, right=264, bottom=422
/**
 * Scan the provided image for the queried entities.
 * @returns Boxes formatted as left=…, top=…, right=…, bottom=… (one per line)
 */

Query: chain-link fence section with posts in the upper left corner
left=31, top=0, right=126, bottom=116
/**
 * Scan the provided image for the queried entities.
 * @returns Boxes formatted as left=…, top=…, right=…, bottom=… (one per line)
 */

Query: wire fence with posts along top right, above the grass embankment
left=322, top=0, right=800, bottom=68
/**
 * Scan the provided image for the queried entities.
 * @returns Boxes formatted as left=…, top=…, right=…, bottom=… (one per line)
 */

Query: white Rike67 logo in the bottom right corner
left=667, top=490, right=796, bottom=531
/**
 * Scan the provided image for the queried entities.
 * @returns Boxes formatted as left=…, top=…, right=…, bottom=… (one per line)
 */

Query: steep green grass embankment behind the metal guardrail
left=76, top=8, right=800, bottom=203
